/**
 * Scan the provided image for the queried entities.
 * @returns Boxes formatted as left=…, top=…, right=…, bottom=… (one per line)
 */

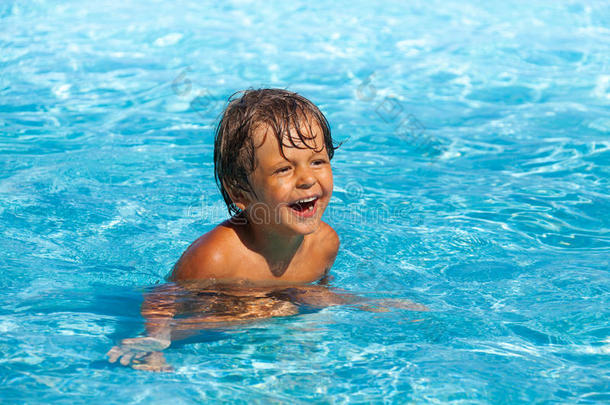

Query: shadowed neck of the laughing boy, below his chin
left=248, top=219, right=305, bottom=277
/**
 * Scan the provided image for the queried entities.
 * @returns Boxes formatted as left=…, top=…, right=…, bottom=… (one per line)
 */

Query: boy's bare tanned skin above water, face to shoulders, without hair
left=170, top=120, right=339, bottom=285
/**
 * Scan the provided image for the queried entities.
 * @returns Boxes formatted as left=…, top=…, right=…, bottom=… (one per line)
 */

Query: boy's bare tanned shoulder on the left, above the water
left=170, top=223, right=241, bottom=281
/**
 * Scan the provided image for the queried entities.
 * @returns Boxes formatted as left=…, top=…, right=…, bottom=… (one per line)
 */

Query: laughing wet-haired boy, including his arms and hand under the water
left=108, top=89, right=344, bottom=371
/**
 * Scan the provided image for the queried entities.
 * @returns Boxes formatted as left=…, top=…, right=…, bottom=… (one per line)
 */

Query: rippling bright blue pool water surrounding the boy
left=0, top=0, right=610, bottom=404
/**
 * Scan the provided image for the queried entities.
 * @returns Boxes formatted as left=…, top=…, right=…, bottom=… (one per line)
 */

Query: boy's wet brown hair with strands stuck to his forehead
left=214, top=89, right=336, bottom=215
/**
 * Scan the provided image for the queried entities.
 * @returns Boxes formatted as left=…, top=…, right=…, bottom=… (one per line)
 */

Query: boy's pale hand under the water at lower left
left=106, top=337, right=171, bottom=371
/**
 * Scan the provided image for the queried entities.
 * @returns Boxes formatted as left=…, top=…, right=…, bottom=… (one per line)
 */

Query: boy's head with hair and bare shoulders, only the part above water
left=171, top=89, right=339, bottom=285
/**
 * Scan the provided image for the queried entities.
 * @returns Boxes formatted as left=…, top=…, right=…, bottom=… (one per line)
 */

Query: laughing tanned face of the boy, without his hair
left=238, top=118, right=333, bottom=235
